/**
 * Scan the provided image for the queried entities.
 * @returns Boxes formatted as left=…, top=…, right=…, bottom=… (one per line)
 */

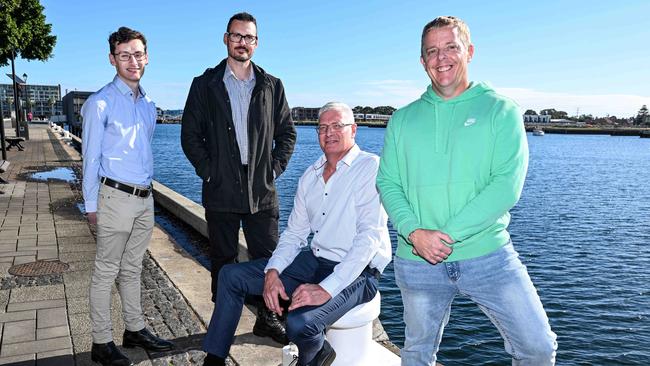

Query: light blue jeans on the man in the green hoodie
left=394, top=243, right=557, bottom=366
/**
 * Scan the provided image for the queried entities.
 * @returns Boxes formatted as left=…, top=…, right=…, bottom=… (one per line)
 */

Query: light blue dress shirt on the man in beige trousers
left=81, top=75, right=156, bottom=212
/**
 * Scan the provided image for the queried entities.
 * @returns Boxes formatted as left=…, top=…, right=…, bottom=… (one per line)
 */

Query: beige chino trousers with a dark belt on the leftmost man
left=90, top=184, right=154, bottom=343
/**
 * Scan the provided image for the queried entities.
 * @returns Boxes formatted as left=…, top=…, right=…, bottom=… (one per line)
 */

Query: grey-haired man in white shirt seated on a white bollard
left=204, top=102, right=391, bottom=366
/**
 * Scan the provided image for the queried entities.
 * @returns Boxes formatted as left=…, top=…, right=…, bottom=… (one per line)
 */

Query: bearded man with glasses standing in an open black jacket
left=181, top=13, right=296, bottom=342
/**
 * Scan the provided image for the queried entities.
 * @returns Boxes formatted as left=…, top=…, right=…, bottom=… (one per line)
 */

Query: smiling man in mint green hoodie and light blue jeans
left=377, top=16, right=557, bottom=366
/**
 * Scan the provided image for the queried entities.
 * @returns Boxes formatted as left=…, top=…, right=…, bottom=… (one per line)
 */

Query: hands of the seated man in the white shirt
left=262, top=269, right=332, bottom=315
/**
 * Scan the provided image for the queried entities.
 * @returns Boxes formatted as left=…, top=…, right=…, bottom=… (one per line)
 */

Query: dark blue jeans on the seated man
left=203, top=251, right=378, bottom=365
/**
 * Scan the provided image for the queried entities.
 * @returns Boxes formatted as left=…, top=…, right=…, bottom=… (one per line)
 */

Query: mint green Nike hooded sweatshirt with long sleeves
left=377, top=83, right=528, bottom=262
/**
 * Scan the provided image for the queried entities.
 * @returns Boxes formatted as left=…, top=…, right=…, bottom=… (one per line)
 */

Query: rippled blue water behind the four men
left=154, top=125, right=650, bottom=365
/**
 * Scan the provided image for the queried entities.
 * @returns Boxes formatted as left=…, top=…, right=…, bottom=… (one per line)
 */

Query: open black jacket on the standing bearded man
left=181, top=59, right=296, bottom=213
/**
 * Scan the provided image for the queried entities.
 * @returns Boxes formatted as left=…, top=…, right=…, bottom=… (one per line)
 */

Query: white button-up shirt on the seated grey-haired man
left=265, top=145, right=391, bottom=297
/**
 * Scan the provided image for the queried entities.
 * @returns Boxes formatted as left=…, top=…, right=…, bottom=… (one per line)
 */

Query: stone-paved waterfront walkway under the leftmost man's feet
left=0, top=125, right=209, bottom=366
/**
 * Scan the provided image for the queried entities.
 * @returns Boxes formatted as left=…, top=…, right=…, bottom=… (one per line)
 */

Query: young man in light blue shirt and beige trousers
left=81, top=27, right=173, bottom=366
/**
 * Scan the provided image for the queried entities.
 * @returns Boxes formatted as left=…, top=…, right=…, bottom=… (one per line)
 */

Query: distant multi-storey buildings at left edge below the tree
left=0, top=84, right=63, bottom=118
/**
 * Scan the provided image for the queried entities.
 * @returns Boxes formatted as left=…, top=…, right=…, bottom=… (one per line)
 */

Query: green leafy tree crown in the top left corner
left=0, top=0, right=56, bottom=66
